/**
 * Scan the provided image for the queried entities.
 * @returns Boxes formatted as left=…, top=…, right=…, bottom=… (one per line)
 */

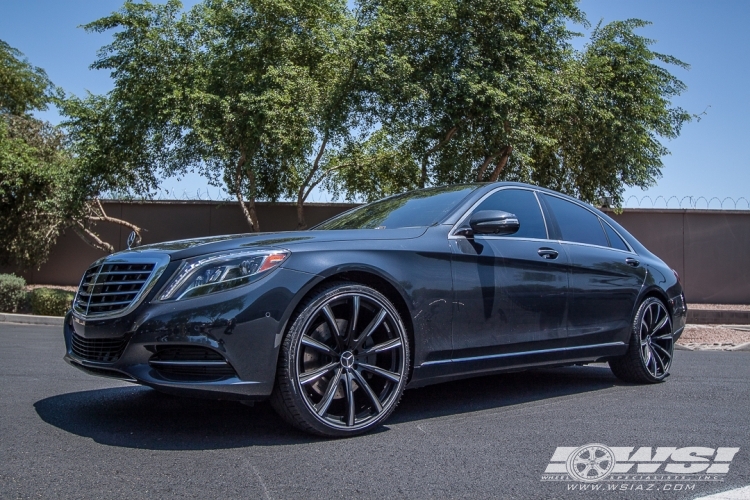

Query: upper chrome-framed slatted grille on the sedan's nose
left=73, top=262, right=155, bottom=317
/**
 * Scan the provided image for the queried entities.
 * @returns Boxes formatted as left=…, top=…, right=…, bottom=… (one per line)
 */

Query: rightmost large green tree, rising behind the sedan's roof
left=330, top=0, right=691, bottom=206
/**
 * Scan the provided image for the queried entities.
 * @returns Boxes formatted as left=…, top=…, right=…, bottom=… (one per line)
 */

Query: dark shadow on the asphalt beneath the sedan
left=34, top=366, right=618, bottom=450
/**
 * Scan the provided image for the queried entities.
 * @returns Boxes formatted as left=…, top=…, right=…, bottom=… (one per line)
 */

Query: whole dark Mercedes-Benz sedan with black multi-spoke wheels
left=64, top=183, right=687, bottom=436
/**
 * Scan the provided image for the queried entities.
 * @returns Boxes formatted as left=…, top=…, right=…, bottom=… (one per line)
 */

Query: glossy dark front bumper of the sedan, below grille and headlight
left=63, top=268, right=315, bottom=400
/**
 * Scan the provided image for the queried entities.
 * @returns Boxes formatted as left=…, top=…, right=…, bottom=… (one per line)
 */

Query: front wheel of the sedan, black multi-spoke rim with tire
left=271, top=283, right=409, bottom=436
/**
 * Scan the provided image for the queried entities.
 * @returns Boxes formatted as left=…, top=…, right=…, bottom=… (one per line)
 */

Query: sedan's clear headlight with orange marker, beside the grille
left=159, top=250, right=289, bottom=300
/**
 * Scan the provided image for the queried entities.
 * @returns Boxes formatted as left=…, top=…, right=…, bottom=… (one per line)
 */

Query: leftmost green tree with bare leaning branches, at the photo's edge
left=0, top=41, right=141, bottom=269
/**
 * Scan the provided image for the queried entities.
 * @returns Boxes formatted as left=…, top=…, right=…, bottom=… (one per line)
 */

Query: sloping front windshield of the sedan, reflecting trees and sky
left=313, top=184, right=477, bottom=229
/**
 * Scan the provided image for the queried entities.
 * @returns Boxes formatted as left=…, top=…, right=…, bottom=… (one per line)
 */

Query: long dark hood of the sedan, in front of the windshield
left=114, top=227, right=427, bottom=261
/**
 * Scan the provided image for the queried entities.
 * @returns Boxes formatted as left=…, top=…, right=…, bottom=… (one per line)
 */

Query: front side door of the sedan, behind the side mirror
left=450, top=187, right=568, bottom=365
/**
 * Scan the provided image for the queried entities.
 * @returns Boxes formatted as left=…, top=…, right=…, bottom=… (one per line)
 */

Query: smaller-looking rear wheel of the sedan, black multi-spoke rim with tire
left=609, top=297, right=674, bottom=383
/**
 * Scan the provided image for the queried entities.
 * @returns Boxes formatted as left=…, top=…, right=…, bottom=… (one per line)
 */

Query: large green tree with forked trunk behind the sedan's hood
left=72, top=0, right=374, bottom=231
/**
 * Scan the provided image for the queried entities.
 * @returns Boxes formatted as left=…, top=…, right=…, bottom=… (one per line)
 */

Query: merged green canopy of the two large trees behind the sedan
left=63, top=0, right=690, bottom=230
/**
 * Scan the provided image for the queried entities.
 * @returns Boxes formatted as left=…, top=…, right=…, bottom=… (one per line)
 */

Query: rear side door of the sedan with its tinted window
left=540, top=193, right=646, bottom=347
